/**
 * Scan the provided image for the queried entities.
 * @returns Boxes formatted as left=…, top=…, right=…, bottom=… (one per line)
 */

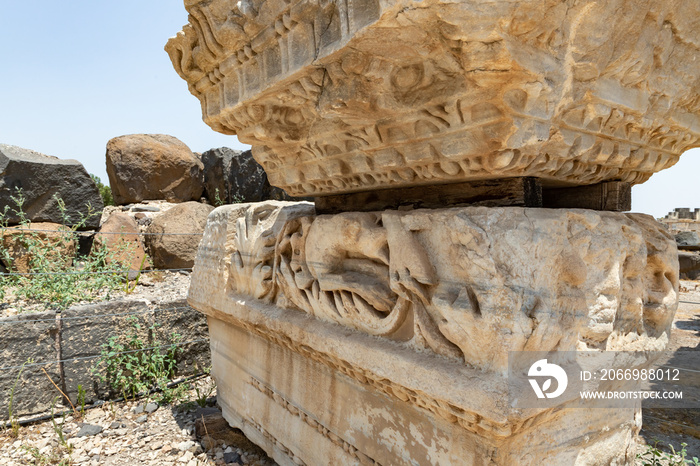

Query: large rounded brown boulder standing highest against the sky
left=106, top=134, right=204, bottom=205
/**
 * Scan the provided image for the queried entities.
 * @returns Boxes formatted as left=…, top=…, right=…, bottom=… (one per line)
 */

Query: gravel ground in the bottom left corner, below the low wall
left=0, top=378, right=276, bottom=466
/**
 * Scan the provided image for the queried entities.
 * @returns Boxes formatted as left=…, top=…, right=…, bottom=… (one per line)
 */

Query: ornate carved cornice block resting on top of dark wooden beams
left=166, top=0, right=700, bottom=196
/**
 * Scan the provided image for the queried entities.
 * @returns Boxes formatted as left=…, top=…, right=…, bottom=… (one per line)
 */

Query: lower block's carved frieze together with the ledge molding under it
left=188, top=201, right=678, bottom=447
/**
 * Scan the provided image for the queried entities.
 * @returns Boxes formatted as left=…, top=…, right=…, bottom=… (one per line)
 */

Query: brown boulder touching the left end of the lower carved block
left=146, top=202, right=214, bottom=269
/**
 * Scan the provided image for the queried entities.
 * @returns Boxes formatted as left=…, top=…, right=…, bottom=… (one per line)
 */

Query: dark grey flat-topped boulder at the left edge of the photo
left=0, top=144, right=104, bottom=230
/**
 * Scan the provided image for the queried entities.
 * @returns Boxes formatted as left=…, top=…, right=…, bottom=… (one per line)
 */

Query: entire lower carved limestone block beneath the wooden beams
left=189, top=202, right=678, bottom=464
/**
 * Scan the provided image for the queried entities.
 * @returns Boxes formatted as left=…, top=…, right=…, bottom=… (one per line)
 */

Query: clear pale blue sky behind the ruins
left=0, top=0, right=700, bottom=217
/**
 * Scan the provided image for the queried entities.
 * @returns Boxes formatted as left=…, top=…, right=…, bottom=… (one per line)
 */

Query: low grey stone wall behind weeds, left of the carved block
left=0, top=298, right=210, bottom=425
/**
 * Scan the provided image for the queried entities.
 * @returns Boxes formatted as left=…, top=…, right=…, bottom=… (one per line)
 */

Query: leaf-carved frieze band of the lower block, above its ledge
left=190, top=201, right=678, bottom=373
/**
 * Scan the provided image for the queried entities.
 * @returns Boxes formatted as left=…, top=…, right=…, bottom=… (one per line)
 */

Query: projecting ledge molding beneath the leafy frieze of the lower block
left=189, top=297, right=516, bottom=438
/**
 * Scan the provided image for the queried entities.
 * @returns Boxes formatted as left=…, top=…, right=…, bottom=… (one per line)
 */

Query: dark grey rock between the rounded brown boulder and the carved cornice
left=202, top=147, right=291, bottom=205
